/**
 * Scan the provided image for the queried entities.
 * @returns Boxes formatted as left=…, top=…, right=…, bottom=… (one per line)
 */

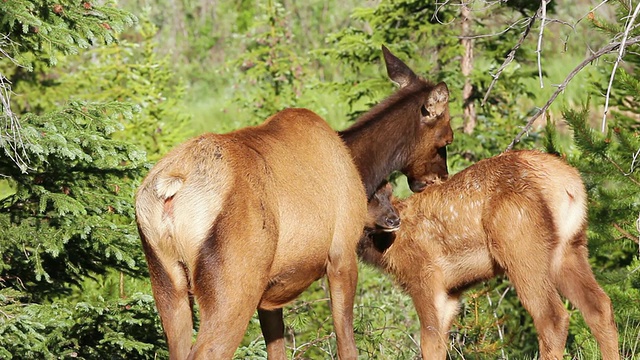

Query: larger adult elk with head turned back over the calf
left=136, top=47, right=453, bottom=359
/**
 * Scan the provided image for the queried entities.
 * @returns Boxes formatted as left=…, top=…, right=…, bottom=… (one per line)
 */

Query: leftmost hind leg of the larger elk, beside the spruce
left=140, top=232, right=193, bottom=360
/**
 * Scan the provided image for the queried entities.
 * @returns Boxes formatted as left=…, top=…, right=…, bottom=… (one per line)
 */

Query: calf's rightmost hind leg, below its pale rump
left=556, top=232, right=620, bottom=360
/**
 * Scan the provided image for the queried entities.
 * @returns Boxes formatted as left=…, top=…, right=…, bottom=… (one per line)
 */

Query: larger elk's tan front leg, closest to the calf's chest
left=327, top=248, right=358, bottom=360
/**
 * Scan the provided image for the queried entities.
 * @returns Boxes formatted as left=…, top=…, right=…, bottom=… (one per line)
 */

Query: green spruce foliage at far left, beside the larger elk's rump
left=0, top=1, right=185, bottom=359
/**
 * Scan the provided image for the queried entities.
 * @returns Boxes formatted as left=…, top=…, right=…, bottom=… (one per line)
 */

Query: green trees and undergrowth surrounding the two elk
left=0, top=0, right=640, bottom=359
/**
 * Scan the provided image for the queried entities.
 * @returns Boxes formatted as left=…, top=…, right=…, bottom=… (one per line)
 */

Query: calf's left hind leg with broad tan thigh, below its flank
left=484, top=200, right=569, bottom=360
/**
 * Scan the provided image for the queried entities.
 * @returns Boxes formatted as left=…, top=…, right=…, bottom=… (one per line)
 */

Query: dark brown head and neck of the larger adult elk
left=339, top=46, right=453, bottom=199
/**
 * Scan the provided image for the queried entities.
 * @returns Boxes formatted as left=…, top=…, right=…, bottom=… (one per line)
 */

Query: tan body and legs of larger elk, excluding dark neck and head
left=136, top=109, right=366, bottom=359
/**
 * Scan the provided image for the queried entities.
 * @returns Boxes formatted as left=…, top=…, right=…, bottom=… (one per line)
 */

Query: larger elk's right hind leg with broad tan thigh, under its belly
left=189, top=211, right=277, bottom=359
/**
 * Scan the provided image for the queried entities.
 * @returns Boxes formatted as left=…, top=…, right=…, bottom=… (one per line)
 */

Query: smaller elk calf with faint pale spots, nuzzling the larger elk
left=358, top=151, right=619, bottom=360
